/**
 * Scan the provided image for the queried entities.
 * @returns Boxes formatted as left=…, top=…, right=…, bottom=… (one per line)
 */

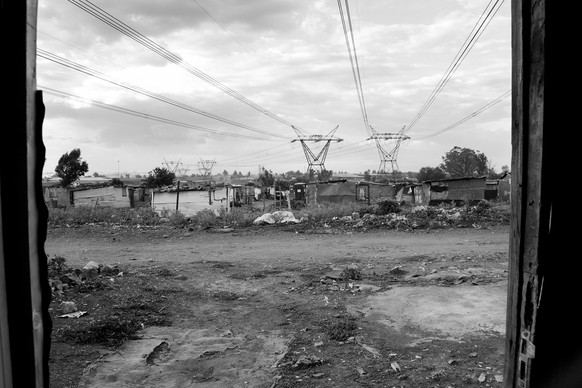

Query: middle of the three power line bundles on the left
left=37, top=49, right=286, bottom=139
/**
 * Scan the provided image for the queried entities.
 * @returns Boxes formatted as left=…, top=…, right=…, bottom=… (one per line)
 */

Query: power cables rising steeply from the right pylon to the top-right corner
left=402, top=0, right=504, bottom=132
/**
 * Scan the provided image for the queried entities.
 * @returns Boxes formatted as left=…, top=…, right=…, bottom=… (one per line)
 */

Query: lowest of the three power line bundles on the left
left=39, top=85, right=274, bottom=140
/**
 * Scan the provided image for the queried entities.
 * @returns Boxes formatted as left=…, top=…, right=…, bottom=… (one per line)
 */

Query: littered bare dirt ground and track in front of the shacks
left=45, top=221, right=509, bottom=388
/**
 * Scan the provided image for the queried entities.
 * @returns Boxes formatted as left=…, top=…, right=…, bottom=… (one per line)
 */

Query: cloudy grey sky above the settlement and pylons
left=37, top=0, right=511, bottom=176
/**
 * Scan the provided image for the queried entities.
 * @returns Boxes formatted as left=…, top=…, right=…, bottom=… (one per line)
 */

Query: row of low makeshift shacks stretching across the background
left=44, top=174, right=510, bottom=215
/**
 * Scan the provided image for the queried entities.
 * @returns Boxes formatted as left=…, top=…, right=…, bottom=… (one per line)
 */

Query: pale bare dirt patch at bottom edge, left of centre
left=78, top=327, right=289, bottom=388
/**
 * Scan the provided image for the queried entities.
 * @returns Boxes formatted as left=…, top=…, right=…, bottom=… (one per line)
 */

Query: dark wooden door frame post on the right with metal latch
left=505, top=0, right=582, bottom=388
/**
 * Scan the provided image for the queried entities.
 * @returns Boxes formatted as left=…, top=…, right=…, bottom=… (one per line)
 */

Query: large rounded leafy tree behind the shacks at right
left=439, top=146, right=489, bottom=178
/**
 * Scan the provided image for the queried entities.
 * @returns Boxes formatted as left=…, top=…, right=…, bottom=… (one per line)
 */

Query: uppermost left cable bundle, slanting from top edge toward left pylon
left=69, top=0, right=304, bottom=135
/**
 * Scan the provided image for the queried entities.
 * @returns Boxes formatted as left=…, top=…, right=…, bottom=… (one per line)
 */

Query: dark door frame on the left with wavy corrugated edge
left=0, top=0, right=51, bottom=388
